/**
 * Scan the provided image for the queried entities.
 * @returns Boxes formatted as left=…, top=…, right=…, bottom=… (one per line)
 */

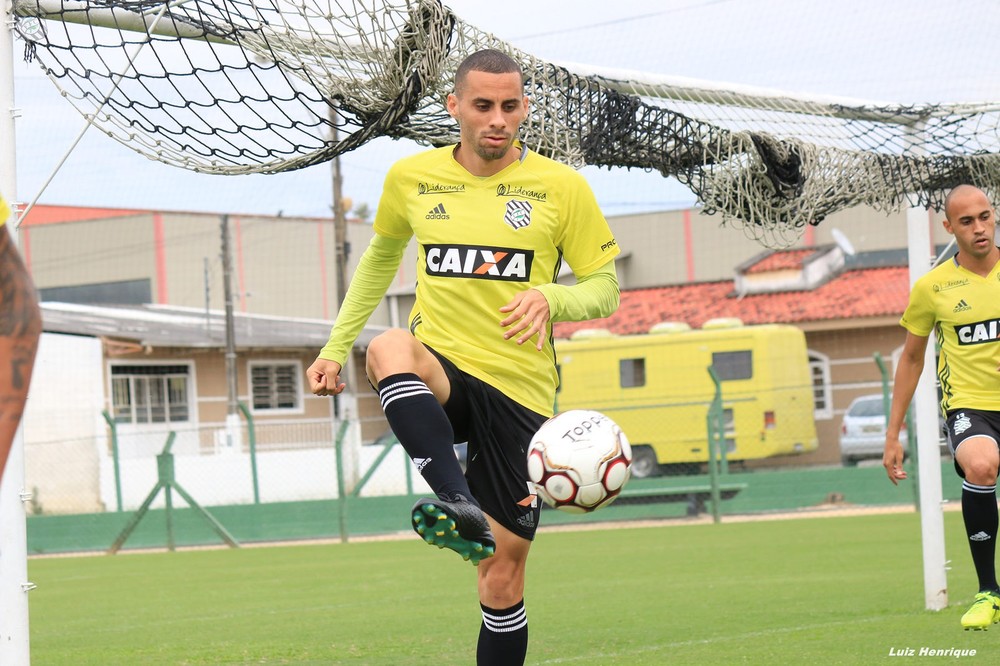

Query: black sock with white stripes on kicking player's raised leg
left=378, top=373, right=475, bottom=502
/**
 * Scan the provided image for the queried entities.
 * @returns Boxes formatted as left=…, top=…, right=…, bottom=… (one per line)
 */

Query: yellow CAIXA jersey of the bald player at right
left=900, top=253, right=1000, bottom=411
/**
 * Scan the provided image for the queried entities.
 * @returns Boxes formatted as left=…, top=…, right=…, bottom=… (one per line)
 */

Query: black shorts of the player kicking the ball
left=428, top=347, right=548, bottom=541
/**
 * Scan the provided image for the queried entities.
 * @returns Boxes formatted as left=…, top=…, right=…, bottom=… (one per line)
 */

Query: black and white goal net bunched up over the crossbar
left=14, top=0, right=1000, bottom=246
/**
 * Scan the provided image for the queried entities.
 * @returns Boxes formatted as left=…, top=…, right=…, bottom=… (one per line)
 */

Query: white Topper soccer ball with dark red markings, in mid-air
left=528, top=409, right=632, bottom=513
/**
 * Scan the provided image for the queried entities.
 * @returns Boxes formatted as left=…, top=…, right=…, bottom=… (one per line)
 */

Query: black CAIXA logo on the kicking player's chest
left=424, top=245, right=535, bottom=282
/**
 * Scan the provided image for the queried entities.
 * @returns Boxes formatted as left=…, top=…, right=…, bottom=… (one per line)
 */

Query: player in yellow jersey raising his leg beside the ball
left=307, top=49, right=619, bottom=666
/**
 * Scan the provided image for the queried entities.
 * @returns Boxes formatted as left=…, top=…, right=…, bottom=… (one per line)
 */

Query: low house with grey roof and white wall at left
left=23, top=302, right=386, bottom=513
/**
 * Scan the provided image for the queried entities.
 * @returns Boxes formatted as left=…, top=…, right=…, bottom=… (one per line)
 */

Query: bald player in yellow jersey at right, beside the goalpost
left=882, top=185, right=1000, bottom=630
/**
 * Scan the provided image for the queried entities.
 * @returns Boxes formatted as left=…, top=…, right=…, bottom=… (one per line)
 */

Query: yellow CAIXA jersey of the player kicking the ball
left=375, top=143, right=619, bottom=415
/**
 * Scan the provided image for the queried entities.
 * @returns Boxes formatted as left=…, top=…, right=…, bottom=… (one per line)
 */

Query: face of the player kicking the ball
left=448, top=72, right=528, bottom=176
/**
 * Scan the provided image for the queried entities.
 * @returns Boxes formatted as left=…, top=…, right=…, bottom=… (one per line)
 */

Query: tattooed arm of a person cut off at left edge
left=0, top=206, right=42, bottom=478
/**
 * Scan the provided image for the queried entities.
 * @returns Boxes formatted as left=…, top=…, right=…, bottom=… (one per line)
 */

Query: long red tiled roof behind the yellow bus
left=555, top=267, right=910, bottom=338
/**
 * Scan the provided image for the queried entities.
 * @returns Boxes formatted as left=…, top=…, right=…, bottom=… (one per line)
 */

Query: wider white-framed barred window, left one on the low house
left=111, top=365, right=190, bottom=424
